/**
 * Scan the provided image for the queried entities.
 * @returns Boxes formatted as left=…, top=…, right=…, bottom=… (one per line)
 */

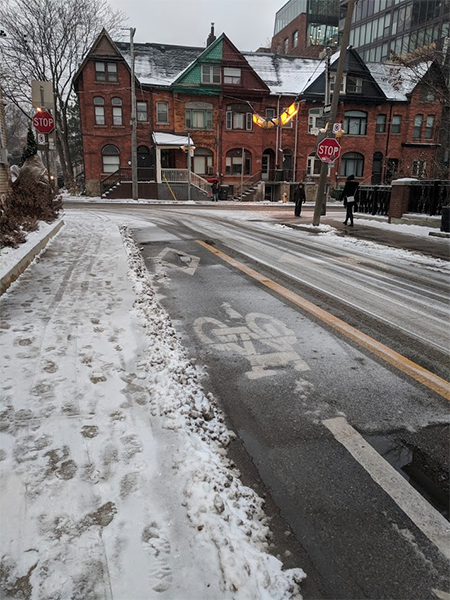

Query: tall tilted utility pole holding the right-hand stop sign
left=313, top=0, right=356, bottom=226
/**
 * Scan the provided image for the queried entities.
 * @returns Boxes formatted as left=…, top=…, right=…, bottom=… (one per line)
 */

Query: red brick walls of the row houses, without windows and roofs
left=76, top=32, right=441, bottom=195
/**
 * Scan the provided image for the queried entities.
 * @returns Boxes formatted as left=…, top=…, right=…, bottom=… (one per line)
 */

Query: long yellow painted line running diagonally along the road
left=197, top=240, right=450, bottom=400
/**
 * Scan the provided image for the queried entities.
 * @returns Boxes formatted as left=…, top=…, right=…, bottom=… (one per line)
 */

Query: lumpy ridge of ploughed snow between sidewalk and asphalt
left=121, top=227, right=306, bottom=600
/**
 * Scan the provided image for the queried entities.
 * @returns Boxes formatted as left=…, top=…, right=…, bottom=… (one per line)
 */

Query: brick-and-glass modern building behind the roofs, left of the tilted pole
left=271, top=0, right=339, bottom=57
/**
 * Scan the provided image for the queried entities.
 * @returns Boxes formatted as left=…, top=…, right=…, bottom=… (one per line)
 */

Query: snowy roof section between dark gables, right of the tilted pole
left=366, top=61, right=431, bottom=101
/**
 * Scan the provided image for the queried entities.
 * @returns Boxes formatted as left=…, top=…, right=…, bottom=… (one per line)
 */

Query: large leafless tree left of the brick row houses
left=0, top=0, right=125, bottom=188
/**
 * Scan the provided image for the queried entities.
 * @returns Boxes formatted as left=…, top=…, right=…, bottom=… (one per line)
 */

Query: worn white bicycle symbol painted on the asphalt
left=194, top=311, right=309, bottom=379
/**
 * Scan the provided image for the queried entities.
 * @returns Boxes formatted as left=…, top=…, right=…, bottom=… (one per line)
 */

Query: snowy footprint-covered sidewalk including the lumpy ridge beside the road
left=0, top=212, right=304, bottom=600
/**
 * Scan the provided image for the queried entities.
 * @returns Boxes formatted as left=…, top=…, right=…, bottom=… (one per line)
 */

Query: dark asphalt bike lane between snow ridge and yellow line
left=136, top=233, right=450, bottom=600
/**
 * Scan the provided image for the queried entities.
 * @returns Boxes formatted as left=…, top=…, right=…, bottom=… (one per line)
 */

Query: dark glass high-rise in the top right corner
left=339, top=0, right=450, bottom=62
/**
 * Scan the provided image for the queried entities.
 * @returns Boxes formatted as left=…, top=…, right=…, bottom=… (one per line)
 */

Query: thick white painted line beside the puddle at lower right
left=323, top=417, right=450, bottom=560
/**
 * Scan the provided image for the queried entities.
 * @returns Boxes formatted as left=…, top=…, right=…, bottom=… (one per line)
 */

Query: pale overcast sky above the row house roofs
left=109, top=0, right=286, bottom=50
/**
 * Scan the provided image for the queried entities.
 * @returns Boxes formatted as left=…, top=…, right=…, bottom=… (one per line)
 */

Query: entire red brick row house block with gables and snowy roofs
left=74, top=29, right=447, bottom=201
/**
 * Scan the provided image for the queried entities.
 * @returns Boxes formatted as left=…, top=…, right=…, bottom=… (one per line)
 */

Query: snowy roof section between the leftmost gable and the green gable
left=115, top=42, right=204, bottom=86
